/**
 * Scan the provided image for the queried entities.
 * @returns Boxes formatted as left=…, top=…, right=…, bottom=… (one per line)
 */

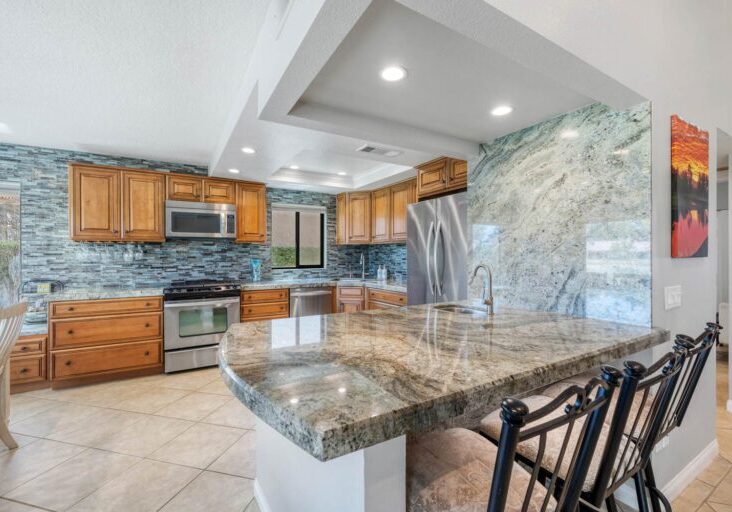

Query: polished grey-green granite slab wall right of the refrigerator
left=468, top=104, right=651, bottom=325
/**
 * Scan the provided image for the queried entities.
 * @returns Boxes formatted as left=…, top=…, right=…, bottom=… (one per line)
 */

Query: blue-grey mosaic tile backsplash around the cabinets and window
left=0, top=144, right=406, bottom=320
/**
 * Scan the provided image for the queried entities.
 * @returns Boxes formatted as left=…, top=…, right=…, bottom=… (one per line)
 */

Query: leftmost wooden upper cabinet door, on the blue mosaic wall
left=69, top=166, right=121, bottom=241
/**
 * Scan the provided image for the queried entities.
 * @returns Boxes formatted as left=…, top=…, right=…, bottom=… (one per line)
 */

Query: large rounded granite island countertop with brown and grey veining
left=219, top=305, right=669, bottom=461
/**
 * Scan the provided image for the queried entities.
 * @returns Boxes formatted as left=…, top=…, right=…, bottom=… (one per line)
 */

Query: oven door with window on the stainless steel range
left=165, top=297, right=239, bottom=350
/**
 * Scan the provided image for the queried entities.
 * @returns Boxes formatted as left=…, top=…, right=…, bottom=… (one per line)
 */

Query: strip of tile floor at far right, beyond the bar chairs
left=673, top=351, right=732, bottom=512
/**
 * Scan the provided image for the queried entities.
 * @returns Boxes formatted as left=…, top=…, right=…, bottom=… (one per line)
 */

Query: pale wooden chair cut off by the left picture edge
left=0, top=302, right=28, bottom=450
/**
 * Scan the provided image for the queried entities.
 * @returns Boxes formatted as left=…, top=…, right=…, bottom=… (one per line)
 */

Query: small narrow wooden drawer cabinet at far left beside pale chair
left=9, top=334, right=48, bottom=393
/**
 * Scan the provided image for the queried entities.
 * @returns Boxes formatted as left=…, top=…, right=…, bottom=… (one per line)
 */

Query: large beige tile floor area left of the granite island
left=0, top=368, right=259, bottom=512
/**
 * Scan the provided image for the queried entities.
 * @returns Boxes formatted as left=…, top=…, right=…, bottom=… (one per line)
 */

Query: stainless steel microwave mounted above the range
left=165, top=201, right=236, bottom=238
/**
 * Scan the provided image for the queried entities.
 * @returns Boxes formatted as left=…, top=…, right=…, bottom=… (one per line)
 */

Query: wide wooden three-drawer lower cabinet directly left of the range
left=48, top=297, right=163, bottom=387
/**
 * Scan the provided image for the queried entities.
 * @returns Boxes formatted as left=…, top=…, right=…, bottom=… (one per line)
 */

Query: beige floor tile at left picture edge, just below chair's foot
left=0, top=439, right=84, bottom=494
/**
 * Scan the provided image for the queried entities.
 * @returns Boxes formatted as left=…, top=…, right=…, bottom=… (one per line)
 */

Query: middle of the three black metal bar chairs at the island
left=481, top=351, right=685, bottom=512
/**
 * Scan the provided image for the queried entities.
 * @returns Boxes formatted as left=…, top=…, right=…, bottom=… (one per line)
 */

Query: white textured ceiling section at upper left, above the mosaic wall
left=0, top=0, right=269, bottom=165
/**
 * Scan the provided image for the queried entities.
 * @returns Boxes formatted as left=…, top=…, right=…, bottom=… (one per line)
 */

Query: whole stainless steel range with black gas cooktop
left=163, top=281, right=241, bottom=373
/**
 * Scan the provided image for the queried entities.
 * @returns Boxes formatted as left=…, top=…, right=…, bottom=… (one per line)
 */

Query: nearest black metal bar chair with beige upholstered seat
left=407, top=367, right=622, bottom=512
